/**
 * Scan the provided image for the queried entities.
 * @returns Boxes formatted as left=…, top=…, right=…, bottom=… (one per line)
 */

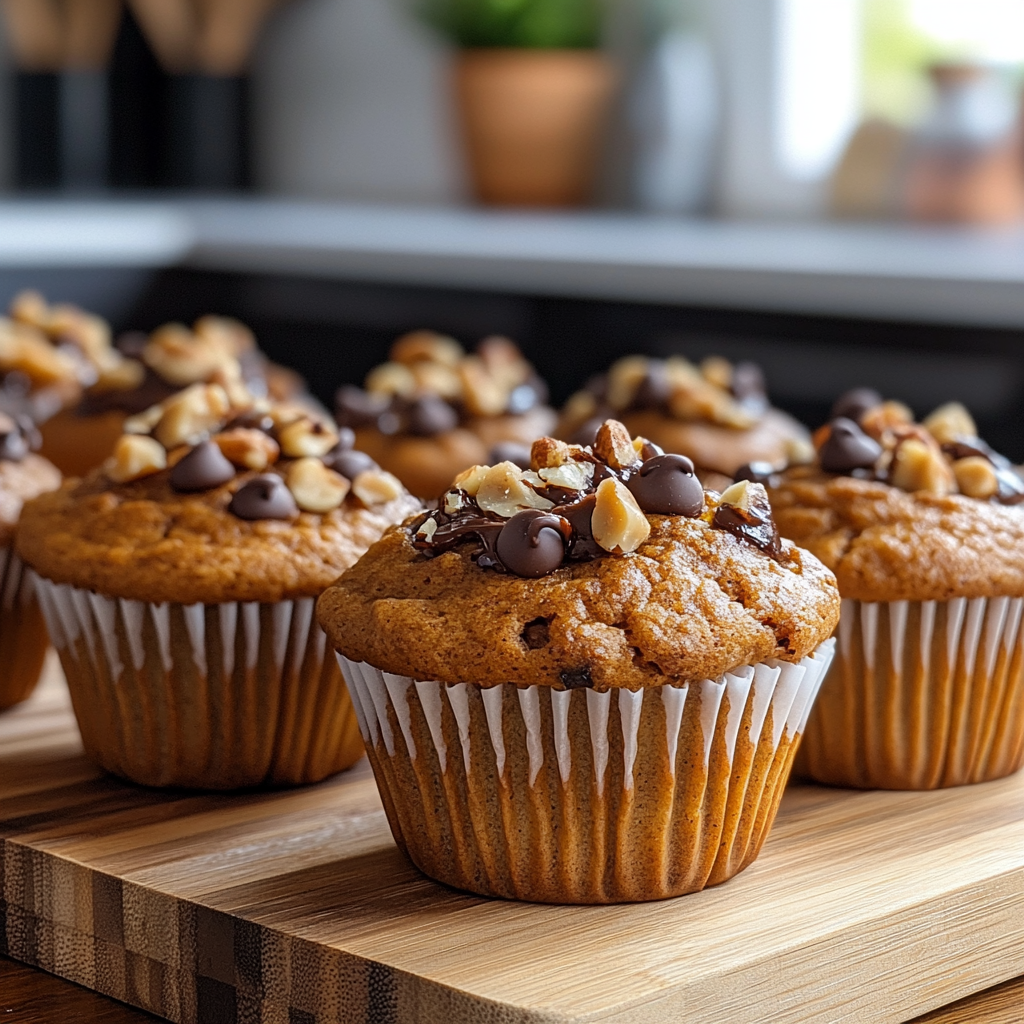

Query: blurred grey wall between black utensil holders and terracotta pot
left=253, top=0, right=464, bottom=203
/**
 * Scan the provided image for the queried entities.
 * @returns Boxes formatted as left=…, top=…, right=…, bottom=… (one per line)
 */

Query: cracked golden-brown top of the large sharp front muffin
left=318, top=421, right=839, bottom=690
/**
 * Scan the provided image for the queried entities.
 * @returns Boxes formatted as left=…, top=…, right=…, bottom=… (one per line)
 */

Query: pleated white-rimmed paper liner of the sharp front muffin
left=339, top=640, right=835, bottom=903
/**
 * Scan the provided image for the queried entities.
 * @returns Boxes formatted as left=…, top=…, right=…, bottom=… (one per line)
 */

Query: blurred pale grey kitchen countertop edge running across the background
left=6, top=199, right=1024, bottom=328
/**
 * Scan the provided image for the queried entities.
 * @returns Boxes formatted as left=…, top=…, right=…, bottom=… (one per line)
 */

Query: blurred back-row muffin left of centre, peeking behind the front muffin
left=336, top=331, right=555, bottom=498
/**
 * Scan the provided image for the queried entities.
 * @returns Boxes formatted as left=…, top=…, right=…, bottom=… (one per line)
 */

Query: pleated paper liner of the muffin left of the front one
left=37, top=578, right=362, bottom=790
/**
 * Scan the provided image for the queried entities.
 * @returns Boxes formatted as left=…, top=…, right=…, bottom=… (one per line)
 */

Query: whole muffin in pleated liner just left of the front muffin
left=17, top=384, right=420, bottom=790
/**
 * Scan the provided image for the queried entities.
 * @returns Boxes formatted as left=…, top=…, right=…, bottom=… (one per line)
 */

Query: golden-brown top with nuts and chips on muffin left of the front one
left=17, top=384, right=421, bottom=604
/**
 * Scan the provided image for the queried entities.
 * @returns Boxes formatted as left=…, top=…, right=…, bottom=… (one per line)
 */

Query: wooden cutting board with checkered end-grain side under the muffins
left=0, top=666, right=1024, bottom=1024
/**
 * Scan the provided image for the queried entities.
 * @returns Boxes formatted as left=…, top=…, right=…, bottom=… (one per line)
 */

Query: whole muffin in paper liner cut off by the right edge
left=765, top=391, right=1024, bottom=790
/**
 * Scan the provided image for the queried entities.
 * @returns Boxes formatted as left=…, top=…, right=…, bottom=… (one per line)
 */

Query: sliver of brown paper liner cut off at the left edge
left=0, top=547, right=49, bottom=711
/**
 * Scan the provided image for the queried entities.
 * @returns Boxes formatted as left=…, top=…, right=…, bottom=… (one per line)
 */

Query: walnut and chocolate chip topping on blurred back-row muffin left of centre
left=336, top=331, right=548, bottom=437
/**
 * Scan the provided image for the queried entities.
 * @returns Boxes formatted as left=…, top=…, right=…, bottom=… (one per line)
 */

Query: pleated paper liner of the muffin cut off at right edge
left=797, top=597, right=1024, bottom=790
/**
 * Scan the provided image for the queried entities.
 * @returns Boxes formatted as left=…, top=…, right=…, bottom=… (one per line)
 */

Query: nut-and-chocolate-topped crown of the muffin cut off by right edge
left=765, top=389, right=1024, bottom=601
